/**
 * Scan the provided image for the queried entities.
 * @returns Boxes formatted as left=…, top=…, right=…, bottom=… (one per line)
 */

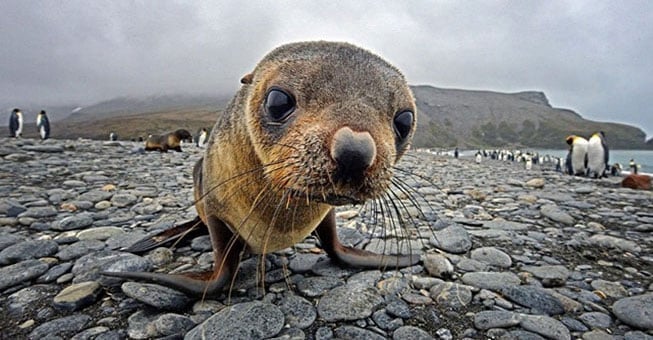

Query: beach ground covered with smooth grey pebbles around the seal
left=0, top=139, right=653, bottom=339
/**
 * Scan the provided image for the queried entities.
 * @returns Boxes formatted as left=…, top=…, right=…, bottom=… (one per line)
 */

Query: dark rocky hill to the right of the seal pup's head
left=412, top=86, right=653, bottom=149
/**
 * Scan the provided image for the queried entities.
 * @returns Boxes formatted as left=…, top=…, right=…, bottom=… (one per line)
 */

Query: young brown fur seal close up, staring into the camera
left=104, top=41, right=420, bottom=295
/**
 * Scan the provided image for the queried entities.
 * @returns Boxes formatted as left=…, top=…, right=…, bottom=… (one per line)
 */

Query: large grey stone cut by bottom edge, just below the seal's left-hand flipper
left=184, top=301, right=284, bottom=340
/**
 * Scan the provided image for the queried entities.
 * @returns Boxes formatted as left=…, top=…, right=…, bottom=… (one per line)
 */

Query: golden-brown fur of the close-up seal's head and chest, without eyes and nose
left=195, top=42, right=416, bottom=253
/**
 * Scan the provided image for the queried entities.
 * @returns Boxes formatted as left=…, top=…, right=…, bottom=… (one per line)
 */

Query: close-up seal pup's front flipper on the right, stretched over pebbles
left=315, top=209, right=420, bottom=269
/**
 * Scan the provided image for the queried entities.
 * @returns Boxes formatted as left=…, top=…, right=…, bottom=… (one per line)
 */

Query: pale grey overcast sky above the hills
left=0, top=0, right=653, bottom=137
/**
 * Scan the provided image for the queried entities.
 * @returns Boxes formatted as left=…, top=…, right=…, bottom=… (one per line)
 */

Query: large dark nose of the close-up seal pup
left=331, top=126, right=376, bottom=182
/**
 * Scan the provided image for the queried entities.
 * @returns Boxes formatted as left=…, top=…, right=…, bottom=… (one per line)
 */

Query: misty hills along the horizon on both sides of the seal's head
left=6, top=86, right=653, bottom=149
